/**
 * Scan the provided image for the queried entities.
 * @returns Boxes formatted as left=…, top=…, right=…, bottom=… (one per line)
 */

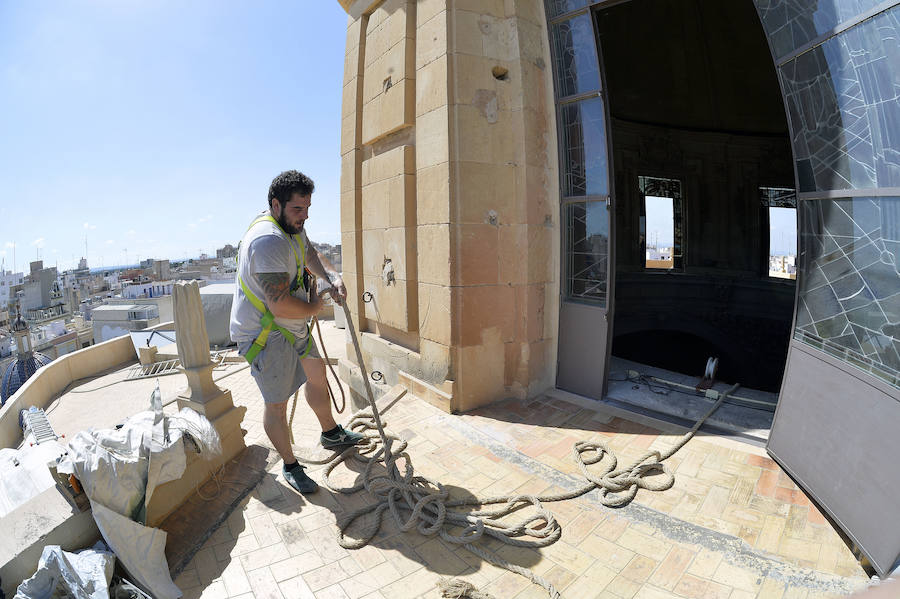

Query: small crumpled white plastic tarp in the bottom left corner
left=13, top=543, right=116, bottom=599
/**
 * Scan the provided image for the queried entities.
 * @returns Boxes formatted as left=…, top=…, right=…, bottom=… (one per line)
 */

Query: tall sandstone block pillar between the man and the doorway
left=341, top=0, right=560, bottom=411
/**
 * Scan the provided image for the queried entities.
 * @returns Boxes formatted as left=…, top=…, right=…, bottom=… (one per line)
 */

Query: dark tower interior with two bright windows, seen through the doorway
left=595, top=0, right=797, bottom=392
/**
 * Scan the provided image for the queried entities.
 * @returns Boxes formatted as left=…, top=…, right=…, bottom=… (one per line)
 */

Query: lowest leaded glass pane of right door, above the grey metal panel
left=794, top=198, right=900, bottom=387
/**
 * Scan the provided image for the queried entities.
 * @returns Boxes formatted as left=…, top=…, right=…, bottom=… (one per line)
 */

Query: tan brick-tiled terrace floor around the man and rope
left=176, top=328, right=866, bottom=599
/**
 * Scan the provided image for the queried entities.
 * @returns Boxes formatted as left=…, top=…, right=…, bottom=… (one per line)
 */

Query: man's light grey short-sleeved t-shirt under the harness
left=230, top=213, right=309, bottom=344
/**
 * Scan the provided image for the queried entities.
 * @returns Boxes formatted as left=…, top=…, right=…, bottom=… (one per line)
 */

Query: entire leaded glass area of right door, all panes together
left=756, top=0, right=900, bottom=387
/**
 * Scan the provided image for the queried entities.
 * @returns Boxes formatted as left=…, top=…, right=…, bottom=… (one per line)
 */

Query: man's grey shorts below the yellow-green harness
left=238, top=331, right=321, bottom=404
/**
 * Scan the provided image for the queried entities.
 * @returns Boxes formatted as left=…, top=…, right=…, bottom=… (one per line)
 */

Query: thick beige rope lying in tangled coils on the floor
left=298, top=303, right=738, bottom=599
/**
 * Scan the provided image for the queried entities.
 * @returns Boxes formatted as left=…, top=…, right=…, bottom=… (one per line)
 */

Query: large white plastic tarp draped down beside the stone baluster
left=58, top=390, right=221, bottom=599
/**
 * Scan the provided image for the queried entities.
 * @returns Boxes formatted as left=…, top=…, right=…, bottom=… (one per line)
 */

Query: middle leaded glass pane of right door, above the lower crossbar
left=779, top=6, right=900, bottom=193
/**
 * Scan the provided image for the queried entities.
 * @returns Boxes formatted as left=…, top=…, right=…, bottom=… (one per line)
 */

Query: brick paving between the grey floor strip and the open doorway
left=462, top=398, right=860, bottom=577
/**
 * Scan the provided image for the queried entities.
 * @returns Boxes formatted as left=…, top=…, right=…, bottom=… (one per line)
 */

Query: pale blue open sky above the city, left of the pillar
left=0, top=0, right=347, bottom=270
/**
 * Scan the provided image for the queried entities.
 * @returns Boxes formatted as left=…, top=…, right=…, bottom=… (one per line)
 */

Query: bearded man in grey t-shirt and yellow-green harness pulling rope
left=230, top=171, right=362, bottom=493
